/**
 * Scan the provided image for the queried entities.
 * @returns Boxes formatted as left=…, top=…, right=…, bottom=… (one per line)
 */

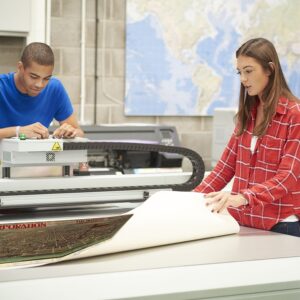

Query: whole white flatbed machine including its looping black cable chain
left=0, top=138, right=204, bottom=213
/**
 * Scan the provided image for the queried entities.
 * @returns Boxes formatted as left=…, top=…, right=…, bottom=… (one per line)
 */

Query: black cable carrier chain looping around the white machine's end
left=0, top=140, right=205, bottom=196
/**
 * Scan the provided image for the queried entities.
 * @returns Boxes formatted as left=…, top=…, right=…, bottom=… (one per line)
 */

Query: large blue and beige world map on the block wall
left=125, top=0, right=300, bottom=116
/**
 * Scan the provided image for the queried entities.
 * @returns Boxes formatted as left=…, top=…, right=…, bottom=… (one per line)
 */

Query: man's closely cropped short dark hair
left=21, top=42, right=54, bottom=68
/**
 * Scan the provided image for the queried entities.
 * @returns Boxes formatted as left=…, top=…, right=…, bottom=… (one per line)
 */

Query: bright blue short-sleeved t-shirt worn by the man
left=0, top=73, right=73, bottom=128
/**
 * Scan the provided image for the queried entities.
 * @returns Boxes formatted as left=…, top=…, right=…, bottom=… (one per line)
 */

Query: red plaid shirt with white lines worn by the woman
left=195, top=98, right=300, bottom=230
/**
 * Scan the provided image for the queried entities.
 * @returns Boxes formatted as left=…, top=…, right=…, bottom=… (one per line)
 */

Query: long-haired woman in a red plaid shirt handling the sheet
left=195, top=38, right=300, bottom=236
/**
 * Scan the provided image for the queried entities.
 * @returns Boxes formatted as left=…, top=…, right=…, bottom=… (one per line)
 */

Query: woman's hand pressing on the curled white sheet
left=204, top=192, right=248, bottom=213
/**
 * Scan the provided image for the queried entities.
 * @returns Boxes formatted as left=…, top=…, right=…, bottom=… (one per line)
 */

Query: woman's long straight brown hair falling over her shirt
left=236, top=38, right=297, bottom=136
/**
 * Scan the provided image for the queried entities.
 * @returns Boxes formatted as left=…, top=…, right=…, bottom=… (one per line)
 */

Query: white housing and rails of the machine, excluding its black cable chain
left=0, top=138, right=191, bottom=209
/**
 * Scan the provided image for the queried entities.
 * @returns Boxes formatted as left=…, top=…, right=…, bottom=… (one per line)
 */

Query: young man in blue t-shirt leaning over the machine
left=0, top=43, right=84, bottom=139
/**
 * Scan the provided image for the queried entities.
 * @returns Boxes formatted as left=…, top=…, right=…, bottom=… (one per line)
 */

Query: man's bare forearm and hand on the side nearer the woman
left=53, top=113, right=84, bottom=138
